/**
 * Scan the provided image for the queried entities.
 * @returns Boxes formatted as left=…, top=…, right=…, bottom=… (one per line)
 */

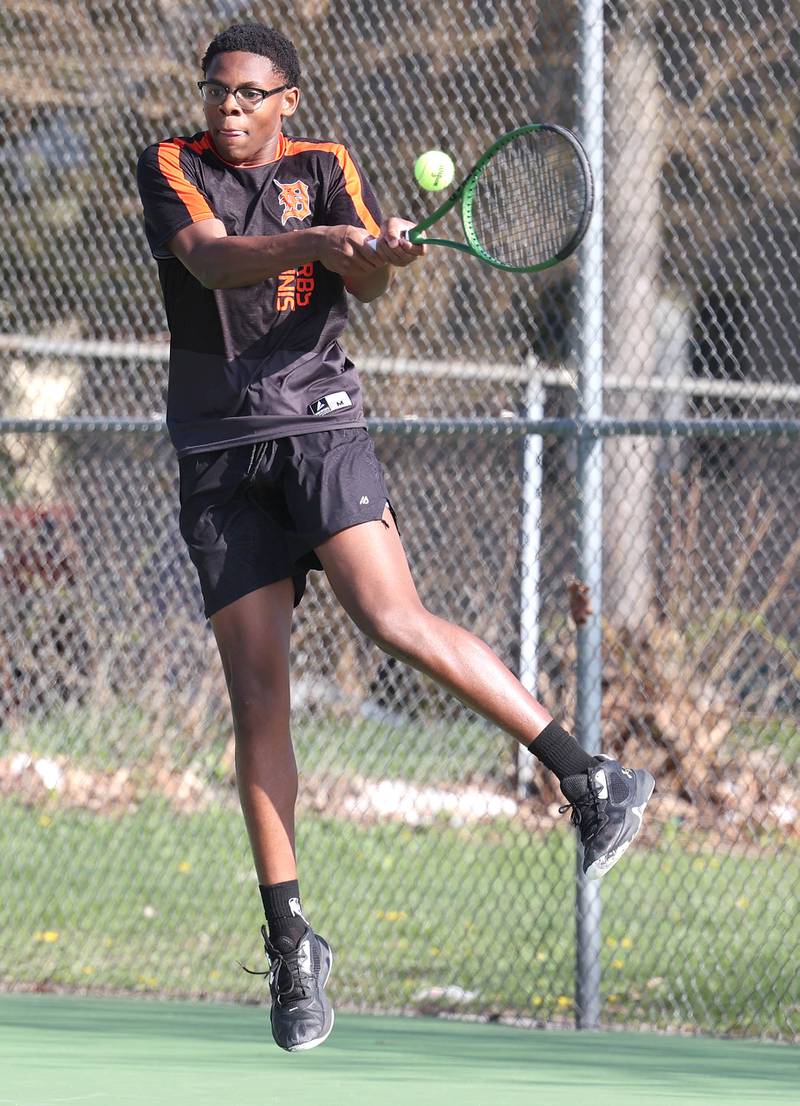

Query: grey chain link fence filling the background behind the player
left=0, top=0, right=800, bottom=1040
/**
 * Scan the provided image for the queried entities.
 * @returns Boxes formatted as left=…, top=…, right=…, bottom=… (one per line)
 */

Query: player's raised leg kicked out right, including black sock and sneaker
left=316, top=508, right=655, bottom=878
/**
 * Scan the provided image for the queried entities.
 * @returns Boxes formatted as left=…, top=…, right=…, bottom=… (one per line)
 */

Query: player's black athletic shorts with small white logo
left=178, top=427, right=394, bottom=618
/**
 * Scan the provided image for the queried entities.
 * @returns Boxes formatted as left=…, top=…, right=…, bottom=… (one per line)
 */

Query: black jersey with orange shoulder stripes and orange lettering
left=137, top=133, right=381, bottom=456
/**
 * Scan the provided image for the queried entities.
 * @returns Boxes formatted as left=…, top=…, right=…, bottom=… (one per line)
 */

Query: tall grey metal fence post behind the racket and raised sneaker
left=575, top=0, right=603, bottom=1029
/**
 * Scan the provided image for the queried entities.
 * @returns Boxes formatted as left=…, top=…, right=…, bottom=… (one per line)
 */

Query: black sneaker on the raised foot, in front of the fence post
left=560, top=754, right=655, bottom=879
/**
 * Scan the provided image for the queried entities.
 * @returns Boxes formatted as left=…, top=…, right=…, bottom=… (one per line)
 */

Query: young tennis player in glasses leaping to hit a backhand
left=138, top=24, right=654, bottom=1052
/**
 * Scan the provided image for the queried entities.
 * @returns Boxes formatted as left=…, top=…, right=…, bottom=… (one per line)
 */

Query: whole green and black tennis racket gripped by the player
left=371, top=123, right=594, bottom=273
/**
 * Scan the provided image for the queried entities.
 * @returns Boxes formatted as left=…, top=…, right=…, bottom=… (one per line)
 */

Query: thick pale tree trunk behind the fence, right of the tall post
left=603, top=12, right=665, bottom=632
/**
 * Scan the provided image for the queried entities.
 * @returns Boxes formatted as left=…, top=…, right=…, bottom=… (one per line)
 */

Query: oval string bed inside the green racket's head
left=471, top=129, right=589, bottom=268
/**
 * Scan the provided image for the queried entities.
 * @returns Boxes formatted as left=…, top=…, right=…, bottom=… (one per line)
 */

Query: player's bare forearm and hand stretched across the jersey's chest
left=167, top=219, right=388, bottom=289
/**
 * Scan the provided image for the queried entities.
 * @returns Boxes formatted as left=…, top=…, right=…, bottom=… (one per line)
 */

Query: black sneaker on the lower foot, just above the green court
left=242, top=926, right=333, bottom=1052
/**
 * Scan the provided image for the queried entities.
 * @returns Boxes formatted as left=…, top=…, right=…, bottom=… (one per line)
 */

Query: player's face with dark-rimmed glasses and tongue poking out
left=202, top=51, right=300, bottom=166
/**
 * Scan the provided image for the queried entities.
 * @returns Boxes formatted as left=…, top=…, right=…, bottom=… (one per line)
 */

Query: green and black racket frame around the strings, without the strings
left=406, top=123, right=594, bottom=273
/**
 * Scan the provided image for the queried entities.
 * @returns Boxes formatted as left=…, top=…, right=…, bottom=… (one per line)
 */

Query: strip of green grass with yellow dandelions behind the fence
left=0, top=799, right=800, bottom=1037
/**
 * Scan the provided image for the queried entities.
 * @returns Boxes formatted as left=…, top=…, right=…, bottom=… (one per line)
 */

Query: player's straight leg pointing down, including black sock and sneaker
left=211, top=580, right=333, bottom=1052
